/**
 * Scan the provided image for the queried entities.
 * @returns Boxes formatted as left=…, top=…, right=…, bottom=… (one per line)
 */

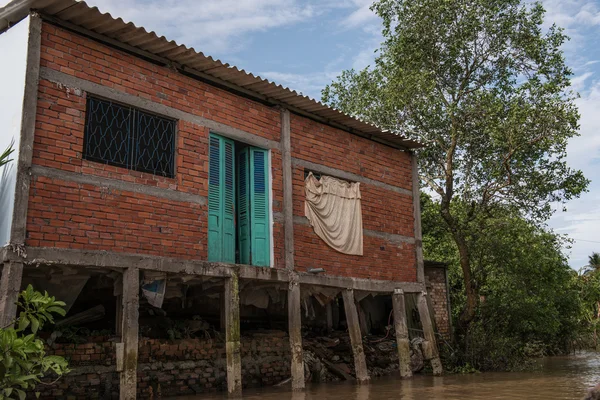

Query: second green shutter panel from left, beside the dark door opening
left=222, top=139, right=235, bottom=264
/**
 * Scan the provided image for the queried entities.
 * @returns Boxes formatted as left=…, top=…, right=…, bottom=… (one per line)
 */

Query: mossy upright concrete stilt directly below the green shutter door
left=224, top=274, right=242, bottom=397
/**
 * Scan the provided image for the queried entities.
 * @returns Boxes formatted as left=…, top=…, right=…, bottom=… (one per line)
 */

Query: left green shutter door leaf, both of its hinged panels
left=208, top=134, right=235, bottom=263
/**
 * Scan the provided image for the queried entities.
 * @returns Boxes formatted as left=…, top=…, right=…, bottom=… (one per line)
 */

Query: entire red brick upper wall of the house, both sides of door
left=27, top=23, right=416, bottom=281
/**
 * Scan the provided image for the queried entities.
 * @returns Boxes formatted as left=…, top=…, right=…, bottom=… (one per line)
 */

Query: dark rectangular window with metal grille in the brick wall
left=83, top=97, right=177, bottom=178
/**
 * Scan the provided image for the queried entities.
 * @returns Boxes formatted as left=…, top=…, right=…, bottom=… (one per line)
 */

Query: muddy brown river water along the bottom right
left=179, top=353, right=600, bottom=400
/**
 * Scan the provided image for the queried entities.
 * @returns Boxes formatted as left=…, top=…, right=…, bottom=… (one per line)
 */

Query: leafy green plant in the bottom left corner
left=0, top=285, right=69, bottom=400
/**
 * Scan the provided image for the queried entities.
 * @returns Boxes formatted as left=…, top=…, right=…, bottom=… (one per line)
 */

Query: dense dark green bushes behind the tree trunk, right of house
left=421, top=194, right=584, bottom=371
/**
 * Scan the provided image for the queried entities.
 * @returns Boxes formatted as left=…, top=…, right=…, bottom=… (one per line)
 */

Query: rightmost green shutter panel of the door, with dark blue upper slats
left=250, top=148, right=271, bottom=267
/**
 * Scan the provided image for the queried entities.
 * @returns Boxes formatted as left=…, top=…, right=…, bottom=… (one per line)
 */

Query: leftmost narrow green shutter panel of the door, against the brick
left=208, top=135, right=223, bottom=261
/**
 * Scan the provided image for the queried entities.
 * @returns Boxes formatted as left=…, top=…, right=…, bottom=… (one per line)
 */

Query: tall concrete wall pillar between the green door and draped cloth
left=281, top=109, right=294, bottom=271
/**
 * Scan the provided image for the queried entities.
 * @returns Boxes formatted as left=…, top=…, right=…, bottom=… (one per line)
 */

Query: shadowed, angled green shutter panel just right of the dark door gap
left=237, top=148, right=250, bottom=264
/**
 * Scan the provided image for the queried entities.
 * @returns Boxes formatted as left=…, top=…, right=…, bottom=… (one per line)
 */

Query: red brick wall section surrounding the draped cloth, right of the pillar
left=291, top=116, right=417, bottom=282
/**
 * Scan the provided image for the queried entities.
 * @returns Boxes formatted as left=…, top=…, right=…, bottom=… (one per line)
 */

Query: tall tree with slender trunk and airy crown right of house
left=322, top=0, right=588, bottom=329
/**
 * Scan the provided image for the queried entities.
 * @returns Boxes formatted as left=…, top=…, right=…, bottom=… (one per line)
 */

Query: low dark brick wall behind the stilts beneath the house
left=37, top=331, right=290, bottom=399
